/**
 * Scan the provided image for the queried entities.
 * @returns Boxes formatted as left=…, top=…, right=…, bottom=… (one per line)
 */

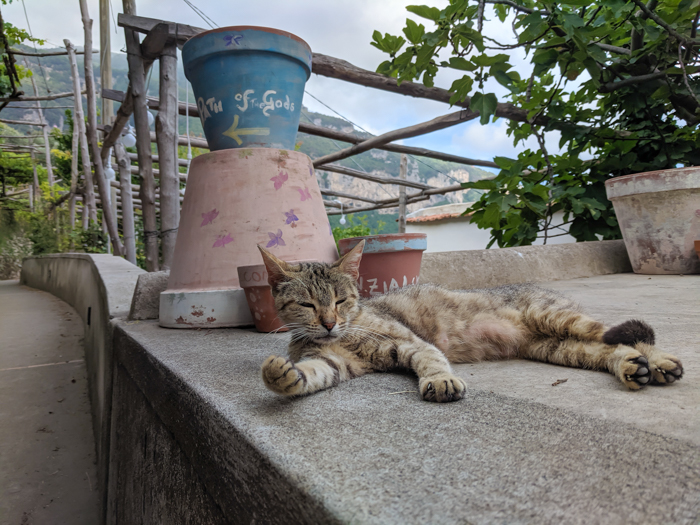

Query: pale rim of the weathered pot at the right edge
left=605, top=166, right=700, bottom=200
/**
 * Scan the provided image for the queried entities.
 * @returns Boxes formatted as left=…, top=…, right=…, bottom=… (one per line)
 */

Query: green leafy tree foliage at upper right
left=372, top=0, right=700, bottom=246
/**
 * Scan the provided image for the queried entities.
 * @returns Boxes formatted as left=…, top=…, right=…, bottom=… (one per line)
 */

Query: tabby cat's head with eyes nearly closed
left=258, top=241, right=365, bottom=344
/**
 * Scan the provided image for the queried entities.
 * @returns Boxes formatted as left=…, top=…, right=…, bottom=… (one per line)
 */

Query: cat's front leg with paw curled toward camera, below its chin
left=262, top=354, right=368, bottom=396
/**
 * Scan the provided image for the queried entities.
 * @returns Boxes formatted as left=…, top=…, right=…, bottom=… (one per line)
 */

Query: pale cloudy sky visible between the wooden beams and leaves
left=2, top=0, right=558, bottom=169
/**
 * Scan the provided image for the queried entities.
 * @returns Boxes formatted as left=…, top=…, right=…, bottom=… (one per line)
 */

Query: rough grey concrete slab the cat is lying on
left=115, top=274, right=700, bottom=524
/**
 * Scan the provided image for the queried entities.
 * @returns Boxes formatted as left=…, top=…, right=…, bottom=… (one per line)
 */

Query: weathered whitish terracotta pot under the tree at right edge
left=605, top=167, right=700, bottom=274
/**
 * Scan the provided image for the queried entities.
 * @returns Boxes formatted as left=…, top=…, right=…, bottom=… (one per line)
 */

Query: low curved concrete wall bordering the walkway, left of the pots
left=20, top=254, right=145, bottom=513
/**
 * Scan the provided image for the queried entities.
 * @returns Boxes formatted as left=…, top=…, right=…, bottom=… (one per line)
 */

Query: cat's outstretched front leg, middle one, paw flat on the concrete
left=394, top=337, right=467, bottom=403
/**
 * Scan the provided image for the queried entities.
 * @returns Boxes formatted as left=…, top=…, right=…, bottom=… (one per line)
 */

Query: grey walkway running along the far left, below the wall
left=0, top=281, right=99, bottom=525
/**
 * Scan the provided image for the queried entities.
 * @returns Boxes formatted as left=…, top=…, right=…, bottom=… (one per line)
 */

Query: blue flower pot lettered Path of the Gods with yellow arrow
left=182, top=26, right=311, bottom=151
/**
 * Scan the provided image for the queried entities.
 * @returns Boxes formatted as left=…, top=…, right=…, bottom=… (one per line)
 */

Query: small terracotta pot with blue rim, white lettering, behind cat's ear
left=338, top=233, right=428, bottom=297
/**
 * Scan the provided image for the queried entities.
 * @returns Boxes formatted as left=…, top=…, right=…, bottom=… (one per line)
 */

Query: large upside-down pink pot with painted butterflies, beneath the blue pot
left=160, top=148, right=338, bottom=328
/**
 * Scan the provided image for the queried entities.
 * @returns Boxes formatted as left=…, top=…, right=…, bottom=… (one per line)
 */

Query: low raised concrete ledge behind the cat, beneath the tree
left=420, top=240, right=632, bottom=290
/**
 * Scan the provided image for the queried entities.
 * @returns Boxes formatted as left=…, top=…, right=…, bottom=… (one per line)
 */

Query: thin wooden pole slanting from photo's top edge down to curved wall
left=80, top=0, right=122, bottom=256
